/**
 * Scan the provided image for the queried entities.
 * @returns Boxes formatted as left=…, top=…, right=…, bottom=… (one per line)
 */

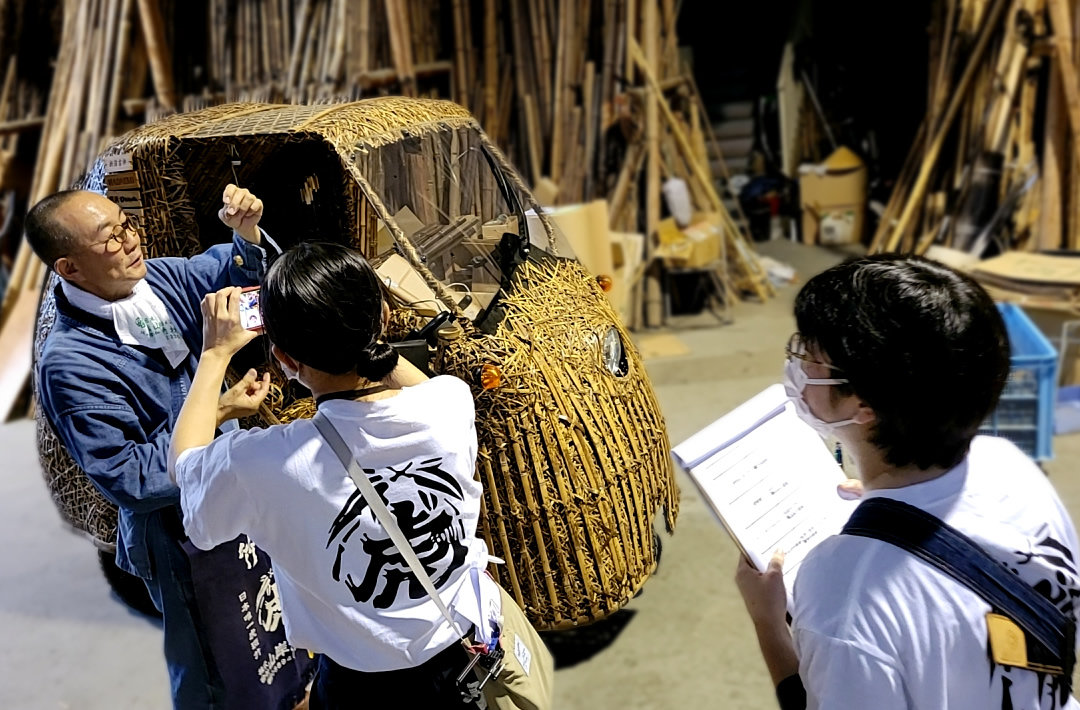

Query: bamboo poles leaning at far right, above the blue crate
left=870, top=0, right=1080, bottom=256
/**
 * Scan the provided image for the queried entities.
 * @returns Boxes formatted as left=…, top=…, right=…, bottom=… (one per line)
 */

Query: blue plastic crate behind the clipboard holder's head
left=978, top=304, right=1057, bottom=460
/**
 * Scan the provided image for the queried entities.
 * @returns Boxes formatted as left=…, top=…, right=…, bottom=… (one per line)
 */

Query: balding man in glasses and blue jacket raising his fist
left=25, top=185, right=272, bottom=710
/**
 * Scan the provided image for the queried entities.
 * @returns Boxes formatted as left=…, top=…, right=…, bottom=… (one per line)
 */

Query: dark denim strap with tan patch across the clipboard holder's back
left=842, top=498, right=1076, bottom=693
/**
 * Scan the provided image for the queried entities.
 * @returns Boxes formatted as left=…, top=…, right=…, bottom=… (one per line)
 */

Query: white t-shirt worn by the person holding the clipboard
left=792, top=437, right=1080, bottom=710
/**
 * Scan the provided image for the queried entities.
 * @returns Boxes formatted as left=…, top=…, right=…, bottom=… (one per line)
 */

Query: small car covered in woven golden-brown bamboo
left=37, top=97, right=678, bottom=629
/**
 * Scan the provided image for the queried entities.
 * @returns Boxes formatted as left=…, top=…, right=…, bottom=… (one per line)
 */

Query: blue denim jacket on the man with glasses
left=37, top=235, right=266, bottom=579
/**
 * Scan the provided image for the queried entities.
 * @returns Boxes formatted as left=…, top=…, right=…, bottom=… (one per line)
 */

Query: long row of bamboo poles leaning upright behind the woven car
left=0, top=0, right=772, bottom=415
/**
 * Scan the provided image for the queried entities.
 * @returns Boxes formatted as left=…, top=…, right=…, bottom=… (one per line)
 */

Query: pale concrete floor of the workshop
left=0, top=242, right=1080, bottom=710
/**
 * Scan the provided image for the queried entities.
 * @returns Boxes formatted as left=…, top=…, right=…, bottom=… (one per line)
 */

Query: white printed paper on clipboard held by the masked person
left=672, top=385, right=859, bottom=609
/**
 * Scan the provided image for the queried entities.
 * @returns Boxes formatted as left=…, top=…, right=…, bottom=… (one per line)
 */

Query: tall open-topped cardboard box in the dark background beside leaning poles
left=799, top=146, right=866, bottom=244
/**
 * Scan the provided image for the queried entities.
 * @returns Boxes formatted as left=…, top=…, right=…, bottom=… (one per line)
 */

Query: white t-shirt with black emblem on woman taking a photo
left=176, top=376, right=498, bottom=672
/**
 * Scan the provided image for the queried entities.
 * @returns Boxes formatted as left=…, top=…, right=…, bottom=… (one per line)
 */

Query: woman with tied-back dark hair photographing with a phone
left=170, top=243, right=514, bottom=710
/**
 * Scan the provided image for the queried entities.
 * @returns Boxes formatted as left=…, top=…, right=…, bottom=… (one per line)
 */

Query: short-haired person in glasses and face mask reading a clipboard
left=735, top=254, right=1080, bottom=710
